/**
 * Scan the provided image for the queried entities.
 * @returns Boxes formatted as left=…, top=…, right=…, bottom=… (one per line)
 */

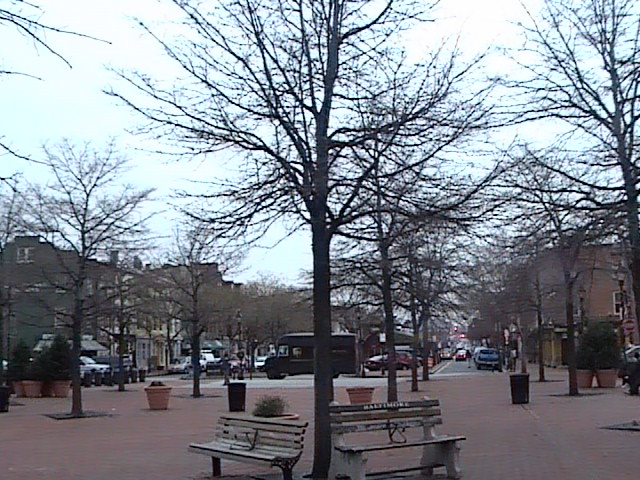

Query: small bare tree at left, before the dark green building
left=22, top=141, right=152, bottom=416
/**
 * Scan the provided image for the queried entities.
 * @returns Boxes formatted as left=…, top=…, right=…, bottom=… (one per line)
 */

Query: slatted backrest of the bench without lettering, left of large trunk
left=217, top=415, right=308, bottom=450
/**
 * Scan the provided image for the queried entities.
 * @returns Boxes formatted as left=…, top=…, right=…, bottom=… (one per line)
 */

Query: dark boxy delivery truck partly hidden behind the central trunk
left=264, top=333, right=356, bottom=380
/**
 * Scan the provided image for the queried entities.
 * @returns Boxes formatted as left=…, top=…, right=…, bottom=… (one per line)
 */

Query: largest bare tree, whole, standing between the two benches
left=109, top=0, right=498, bottom=478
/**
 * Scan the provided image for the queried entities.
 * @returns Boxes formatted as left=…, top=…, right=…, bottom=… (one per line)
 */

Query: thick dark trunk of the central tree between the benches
left=311, top=216, right=333, bottom=479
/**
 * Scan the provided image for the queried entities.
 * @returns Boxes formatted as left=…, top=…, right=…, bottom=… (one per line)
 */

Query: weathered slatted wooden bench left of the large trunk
left=189, top=414, right=308, bottom=480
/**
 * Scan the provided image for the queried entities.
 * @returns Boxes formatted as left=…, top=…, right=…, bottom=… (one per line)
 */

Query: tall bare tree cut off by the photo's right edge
left=513, top=0, right=640, bottom=334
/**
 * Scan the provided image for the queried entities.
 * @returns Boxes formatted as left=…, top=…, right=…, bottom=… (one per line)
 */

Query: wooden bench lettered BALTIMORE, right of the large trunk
left=329, top=398, right=465, bottom=480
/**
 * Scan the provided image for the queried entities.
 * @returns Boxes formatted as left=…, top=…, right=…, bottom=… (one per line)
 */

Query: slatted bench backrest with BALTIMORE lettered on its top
left=329, top=400, right=442, bottom=434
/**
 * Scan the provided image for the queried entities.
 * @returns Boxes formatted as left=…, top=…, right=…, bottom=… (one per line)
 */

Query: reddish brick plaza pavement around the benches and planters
left=0, top=366, right=640, bottom=480
